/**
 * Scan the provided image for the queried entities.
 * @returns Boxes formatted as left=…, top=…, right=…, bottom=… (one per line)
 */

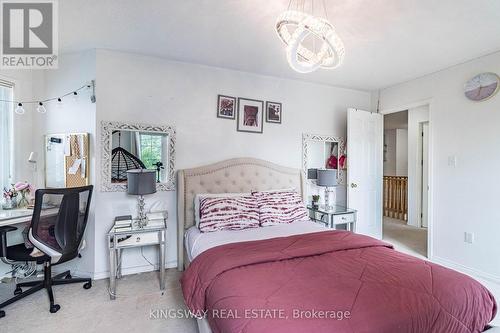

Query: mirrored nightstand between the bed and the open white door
left=307, top=205, right=356, bottom=231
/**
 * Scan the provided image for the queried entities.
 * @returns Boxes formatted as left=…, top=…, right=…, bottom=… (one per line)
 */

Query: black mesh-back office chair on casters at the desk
left=0, top=186, right=93, bottom=318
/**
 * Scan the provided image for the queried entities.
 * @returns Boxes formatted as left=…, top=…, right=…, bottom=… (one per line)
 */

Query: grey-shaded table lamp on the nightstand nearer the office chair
left=127, top=169, right=156, bottom=228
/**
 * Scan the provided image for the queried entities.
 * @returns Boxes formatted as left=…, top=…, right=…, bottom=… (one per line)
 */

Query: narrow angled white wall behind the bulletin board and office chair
left=32, top=51, right=97, bottom=276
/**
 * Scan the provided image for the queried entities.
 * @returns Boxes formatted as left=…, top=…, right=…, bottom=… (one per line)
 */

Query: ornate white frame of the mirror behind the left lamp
left=101, top=121, right=175, bottom=192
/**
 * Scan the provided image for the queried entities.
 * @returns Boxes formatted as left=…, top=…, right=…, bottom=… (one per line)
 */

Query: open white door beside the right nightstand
left=347, top=109, right=384, bottom=239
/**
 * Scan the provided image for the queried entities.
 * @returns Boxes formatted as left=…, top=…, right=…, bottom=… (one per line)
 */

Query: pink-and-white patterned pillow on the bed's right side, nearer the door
left=252, top=190, right=308, bottom=227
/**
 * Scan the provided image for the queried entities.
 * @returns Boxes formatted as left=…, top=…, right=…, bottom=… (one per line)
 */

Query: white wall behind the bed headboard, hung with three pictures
left=95, top=50, right=370, bottom=277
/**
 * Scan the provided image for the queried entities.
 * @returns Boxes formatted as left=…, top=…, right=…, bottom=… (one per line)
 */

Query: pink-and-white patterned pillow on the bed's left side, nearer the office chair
left=198, top=195, right=259, bottom=232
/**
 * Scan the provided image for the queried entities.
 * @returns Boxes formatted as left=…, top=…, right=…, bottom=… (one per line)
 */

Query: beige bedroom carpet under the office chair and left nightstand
left=0, top=269, right=197, bottom=333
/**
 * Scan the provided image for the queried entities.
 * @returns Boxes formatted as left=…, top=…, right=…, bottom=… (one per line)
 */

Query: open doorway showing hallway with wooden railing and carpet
left=383, top=106, right=429, bottom=257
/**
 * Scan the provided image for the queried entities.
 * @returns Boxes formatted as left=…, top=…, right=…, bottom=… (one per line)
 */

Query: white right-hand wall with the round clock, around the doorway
left=381, top=52, right=500, bottom=281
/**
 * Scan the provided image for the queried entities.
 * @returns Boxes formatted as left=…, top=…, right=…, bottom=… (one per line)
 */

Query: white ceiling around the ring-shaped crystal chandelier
left=59, top=0, right=500, bottom=90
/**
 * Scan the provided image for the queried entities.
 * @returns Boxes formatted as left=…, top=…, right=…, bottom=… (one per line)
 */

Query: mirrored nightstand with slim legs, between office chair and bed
left=108, top=218, right=167, bottom=300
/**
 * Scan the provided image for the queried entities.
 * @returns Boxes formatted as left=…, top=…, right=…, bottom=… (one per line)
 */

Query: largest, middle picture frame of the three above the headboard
left=236, top=97, right=264, bottom=133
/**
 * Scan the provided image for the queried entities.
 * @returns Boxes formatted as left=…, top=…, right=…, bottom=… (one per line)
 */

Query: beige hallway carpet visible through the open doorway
left=383, top=217, right=427, bottom=258
